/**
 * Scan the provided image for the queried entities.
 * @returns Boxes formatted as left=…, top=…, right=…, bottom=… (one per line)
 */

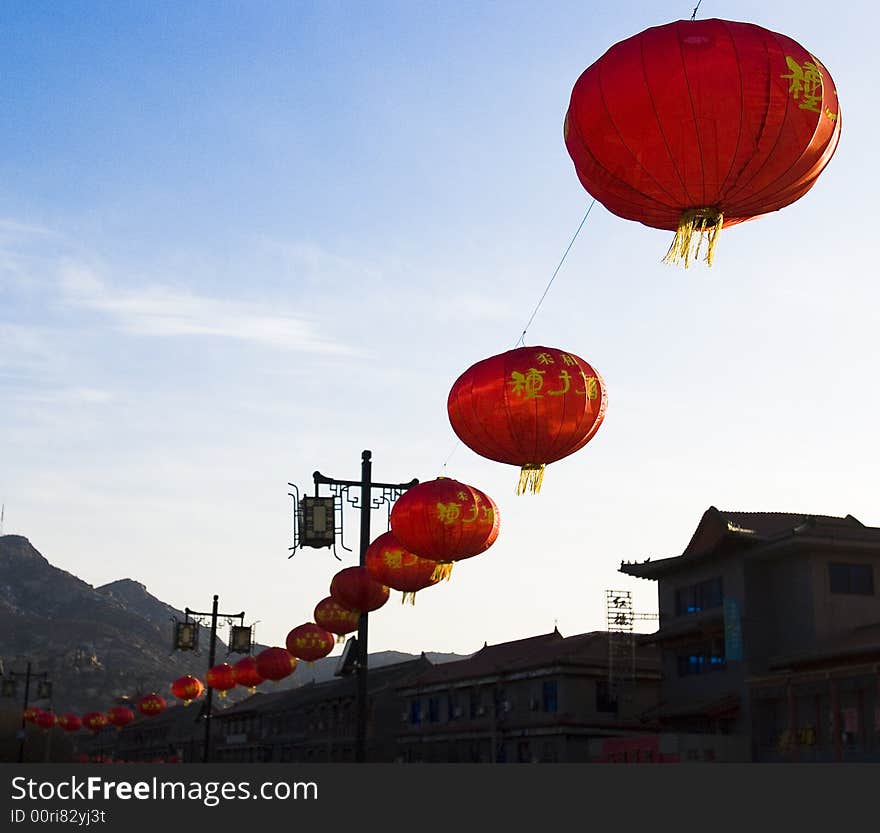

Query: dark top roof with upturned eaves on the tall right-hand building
left=620, top=506, right=880, bottom=579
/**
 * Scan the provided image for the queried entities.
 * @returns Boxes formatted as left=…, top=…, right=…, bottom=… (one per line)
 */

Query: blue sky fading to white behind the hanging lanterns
left=0, top=0, right=880, bottom=653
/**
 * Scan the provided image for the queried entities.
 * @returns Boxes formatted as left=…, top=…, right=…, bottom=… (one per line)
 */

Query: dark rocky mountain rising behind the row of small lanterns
left=0, top=535, right=462, bottom=713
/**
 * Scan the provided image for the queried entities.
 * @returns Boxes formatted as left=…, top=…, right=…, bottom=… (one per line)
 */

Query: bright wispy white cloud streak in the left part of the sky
left=59, top=263, right=355, bottom=354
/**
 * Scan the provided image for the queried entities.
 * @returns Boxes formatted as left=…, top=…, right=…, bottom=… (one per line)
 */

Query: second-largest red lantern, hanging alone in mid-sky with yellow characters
left=446, top=347, right=608, bottom=494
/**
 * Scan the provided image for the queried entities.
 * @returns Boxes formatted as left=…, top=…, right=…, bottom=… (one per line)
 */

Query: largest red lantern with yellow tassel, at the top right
left=565, top=20, right=841, bottom=266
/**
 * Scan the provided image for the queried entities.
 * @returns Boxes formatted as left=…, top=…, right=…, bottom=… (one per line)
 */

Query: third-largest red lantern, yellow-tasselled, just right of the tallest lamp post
left=391, top=477, right=499, bottom=578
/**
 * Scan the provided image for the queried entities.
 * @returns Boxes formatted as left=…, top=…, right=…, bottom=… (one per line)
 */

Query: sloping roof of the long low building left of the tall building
left=396, top=629, right=659, bottom=688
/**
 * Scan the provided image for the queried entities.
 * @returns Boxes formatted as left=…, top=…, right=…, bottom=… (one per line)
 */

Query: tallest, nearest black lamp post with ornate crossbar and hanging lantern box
left=289, top=451, right=419, bottom=763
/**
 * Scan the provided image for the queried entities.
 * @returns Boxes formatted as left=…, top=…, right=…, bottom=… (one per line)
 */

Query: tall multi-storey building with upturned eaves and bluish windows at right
left=620, top=507, right=880, bottom=761
